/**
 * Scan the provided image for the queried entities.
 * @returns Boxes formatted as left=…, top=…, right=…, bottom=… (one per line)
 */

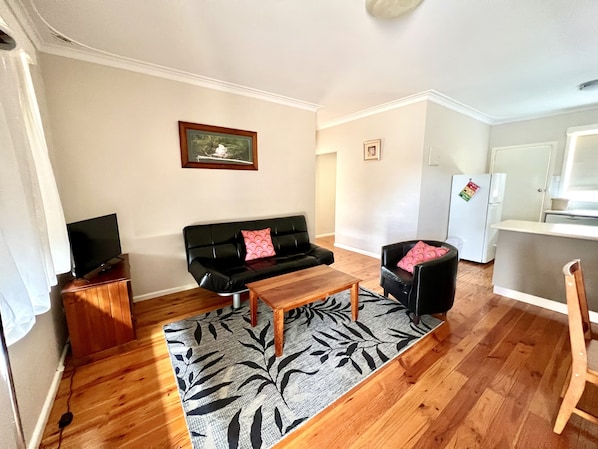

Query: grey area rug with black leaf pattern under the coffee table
left=164, top=288, right=441, bottom=449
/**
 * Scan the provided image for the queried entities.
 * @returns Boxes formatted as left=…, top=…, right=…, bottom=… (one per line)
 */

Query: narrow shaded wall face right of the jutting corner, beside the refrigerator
left=417, top=102, right=490, bottom=240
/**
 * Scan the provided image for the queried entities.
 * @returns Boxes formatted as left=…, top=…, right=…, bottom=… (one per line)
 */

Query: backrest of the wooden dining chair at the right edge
left=563, top=259, right=592, bottom=373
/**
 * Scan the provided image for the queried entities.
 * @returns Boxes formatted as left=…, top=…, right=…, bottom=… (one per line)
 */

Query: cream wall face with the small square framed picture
left=317, top=102, right=427, bottom=256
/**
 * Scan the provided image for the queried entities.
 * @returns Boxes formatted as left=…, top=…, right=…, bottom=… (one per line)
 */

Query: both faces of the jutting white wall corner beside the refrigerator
left=317, top=101, right=489, bottom=256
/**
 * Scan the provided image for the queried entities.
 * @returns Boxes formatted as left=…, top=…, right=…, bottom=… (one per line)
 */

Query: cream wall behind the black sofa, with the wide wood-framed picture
left=42, top=55, right=315, bottom=298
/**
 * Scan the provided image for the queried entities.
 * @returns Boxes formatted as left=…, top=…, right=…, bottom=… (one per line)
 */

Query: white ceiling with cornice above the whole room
left=7, top=0, right=598, bottom=127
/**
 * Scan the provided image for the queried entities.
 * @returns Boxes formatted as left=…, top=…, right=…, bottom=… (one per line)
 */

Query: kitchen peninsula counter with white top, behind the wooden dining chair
left=492, top=219, right=598, bottom=316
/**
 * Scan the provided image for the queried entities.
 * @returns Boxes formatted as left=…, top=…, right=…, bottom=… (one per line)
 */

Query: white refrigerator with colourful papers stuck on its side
left=448, top=173, right=507, bottom=263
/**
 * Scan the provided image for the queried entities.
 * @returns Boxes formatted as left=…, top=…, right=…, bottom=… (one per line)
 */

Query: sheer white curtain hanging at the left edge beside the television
left=0, top=50, right=71, bottom=345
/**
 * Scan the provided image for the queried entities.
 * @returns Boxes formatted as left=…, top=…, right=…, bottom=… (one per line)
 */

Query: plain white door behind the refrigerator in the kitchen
left=490, top=142, right=556, bottom=221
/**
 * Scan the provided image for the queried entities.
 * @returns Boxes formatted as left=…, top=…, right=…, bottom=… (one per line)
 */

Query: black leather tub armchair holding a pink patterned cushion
left=380, top=240, right=459, bottom=324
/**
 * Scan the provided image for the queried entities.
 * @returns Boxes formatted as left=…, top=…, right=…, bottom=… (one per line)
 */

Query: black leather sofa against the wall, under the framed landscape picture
left=183, top=215, right=334, bottom=307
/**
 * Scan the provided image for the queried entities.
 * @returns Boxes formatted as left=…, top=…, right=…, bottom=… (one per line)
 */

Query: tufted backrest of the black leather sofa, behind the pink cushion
left=183, top=215, right=310, bottom=265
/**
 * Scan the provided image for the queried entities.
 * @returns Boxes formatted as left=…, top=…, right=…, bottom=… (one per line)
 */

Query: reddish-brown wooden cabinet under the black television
left=62, top=254, right=137, bottom=365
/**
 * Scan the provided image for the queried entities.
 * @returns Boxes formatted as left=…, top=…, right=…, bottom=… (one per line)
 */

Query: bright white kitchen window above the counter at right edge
left=561, top=125, right=598, bottom=202
